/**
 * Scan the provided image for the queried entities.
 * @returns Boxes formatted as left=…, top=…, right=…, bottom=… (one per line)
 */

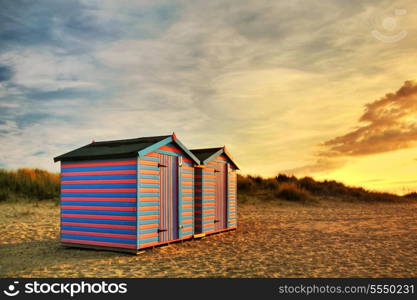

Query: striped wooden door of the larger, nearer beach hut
left=158, top=154, right=178, bottom=242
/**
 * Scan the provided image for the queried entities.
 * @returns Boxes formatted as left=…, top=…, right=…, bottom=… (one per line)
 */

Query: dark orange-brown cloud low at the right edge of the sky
left=321, top=81, right=417, bottom=157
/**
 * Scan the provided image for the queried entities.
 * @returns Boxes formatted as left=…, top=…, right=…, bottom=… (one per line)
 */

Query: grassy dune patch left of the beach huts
left=0, top=168, right=59, bottom=201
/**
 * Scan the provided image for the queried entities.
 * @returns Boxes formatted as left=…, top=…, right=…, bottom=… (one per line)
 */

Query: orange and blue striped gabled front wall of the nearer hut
left=137, top=143, right=194, bottom=248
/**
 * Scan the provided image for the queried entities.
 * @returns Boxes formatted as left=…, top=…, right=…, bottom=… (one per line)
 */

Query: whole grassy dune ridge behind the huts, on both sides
left=0, top=168, right=417, bottom=203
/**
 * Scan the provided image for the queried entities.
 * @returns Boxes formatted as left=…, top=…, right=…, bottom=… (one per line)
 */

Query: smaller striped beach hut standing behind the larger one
left=191, top=147, right=239, bottom=237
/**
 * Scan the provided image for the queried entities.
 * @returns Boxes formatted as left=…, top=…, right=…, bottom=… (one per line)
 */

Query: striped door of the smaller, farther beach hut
left=214, top=163, right=227, bottom=230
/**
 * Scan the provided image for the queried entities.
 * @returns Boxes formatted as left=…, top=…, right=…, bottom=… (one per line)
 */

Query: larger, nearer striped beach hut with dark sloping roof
left=54, top=133, right=199, bottom=252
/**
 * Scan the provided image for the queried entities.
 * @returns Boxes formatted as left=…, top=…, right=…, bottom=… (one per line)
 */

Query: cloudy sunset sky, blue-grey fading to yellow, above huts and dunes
left=0, top=0, right=417, bottom=194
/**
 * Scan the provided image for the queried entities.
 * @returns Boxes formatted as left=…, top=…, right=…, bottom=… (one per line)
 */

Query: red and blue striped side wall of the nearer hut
left=61, top=158, right=137, bottom=249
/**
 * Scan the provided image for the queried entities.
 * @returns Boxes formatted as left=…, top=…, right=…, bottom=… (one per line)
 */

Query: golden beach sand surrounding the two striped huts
left=0, top=203, right=417, bottom=277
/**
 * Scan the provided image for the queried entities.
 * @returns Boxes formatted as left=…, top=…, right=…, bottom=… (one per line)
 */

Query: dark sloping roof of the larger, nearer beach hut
left=54, top=135, right=170, bottom=162
